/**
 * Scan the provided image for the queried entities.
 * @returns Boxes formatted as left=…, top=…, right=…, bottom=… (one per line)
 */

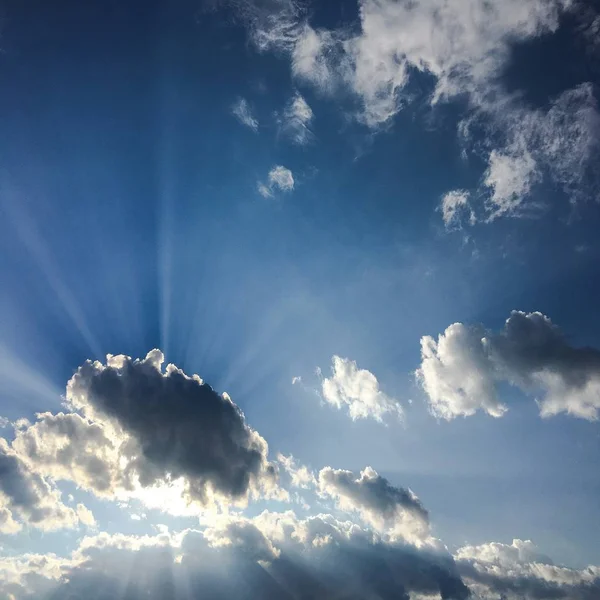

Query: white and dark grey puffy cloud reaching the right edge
left=417, top=311, right=600, bottom=420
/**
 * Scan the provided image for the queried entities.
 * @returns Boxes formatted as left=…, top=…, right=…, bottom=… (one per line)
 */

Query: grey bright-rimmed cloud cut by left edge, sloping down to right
left=0, top=438, right=93, bottom=534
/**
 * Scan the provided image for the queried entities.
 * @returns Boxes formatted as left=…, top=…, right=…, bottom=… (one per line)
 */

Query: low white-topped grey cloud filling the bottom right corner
left=455, top=540, right=600, bottom=600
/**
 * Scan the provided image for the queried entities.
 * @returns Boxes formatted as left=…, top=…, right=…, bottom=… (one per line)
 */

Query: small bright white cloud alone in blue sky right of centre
left=321, top=356, right=404, bottom=422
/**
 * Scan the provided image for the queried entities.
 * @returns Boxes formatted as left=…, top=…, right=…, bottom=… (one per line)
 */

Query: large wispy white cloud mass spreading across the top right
left=226, top=0, right=600, bottom=224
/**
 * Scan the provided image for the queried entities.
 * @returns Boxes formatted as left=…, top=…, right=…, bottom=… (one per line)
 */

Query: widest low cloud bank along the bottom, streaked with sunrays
left=0, top=511, right=468, bottom=600
